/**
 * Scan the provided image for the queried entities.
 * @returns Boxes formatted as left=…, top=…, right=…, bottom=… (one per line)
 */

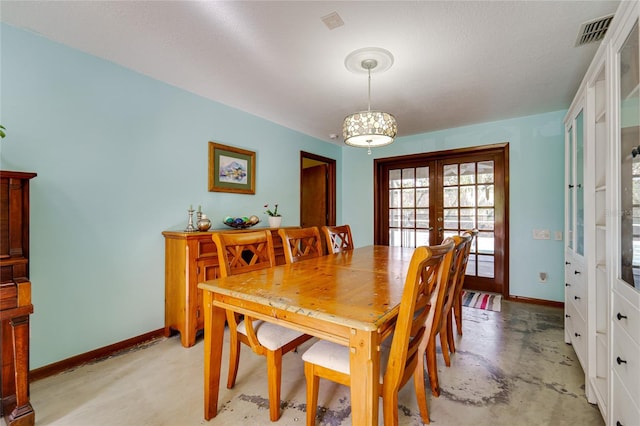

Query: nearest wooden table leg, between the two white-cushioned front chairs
left=349, top=329, right=380, bottom=426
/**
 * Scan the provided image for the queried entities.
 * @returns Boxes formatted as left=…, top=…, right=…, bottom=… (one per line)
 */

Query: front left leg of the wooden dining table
left=202, top=290, right=225, bottom=420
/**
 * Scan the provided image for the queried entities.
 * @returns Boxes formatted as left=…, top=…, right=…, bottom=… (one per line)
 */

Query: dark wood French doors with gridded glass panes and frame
left=374, top=144, right=508, bottom=296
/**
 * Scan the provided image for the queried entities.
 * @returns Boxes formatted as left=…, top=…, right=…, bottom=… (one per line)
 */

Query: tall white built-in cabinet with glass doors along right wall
left=565, top=1, right=640, bottom=426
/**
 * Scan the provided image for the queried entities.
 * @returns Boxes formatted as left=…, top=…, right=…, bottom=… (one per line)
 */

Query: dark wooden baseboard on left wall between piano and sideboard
left=29, top=328, right=165, bottom=382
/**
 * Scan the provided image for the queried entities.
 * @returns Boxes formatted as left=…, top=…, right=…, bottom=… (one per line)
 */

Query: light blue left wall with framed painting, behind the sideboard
left=0, top=24, right=342, bottom=369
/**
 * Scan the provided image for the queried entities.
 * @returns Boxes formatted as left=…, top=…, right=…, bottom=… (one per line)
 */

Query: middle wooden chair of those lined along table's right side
left=438, top=232, right=471, bottom=367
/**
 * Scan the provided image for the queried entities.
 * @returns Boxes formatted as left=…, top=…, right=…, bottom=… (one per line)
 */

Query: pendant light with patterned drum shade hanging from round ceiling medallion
left=342, top=47, right=398, bottom=154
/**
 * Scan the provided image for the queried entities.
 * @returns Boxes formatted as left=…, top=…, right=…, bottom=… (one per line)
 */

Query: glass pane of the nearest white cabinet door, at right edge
left=618, top=21, right=640, bottom=289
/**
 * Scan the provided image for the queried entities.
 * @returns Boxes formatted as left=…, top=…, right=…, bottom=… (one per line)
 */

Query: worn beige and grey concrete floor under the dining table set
left=31, top=301, right=604, bottom=426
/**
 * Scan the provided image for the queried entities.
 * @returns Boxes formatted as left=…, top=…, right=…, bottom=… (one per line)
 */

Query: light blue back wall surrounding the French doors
left=342, top=110, right=566, bottom=301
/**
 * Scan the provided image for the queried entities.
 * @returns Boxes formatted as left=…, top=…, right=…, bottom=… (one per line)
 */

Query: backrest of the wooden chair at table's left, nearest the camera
left=212, top=231, right=276, bottom=277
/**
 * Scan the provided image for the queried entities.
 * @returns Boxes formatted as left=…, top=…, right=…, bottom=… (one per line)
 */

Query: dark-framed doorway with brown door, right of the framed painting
left=300, top=151, right=336, bottom=228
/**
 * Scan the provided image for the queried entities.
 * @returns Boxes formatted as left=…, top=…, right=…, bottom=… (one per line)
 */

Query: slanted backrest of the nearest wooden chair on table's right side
left=383, top=239, right=454, bottom=397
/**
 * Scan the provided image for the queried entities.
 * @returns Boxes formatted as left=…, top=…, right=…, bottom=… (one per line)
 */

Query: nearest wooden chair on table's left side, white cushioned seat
left=213, top=231, right=312, bottom=421
